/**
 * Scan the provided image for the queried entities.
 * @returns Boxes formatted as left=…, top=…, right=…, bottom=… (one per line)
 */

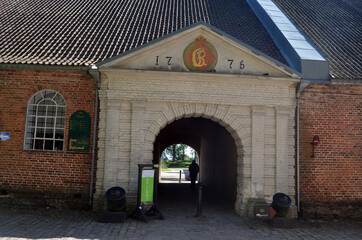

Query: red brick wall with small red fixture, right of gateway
left=300, top=84, right=362, bottom=218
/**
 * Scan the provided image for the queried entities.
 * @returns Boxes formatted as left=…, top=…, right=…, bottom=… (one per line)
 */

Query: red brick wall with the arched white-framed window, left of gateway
left=0, top=66, right=97, bottom=207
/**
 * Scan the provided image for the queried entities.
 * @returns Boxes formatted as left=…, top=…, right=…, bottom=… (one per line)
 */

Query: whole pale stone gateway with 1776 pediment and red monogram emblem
left=94, top=24, right=300, bottom=215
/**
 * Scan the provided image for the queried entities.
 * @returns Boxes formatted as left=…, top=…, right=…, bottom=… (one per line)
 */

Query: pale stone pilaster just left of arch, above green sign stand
left=128, top=101, right=146, bottom=203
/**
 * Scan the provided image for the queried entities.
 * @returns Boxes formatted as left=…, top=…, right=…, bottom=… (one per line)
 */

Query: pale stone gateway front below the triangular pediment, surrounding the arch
left=94, top=70, right=295, bottom=218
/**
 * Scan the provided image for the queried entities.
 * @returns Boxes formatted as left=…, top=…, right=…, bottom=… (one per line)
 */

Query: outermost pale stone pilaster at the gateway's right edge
left=275, top=107, right=289, bottom=194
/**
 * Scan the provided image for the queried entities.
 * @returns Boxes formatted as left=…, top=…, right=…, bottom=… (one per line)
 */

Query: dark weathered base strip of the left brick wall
left=0, top=192, right=90, bottom=210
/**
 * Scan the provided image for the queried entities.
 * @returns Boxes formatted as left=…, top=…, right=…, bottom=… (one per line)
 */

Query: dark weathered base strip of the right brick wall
left=301, top=201, right=362, bottom=220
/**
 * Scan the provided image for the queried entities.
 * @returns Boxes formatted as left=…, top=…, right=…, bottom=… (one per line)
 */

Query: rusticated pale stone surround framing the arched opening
left=144, top=104, right=251, bottom=214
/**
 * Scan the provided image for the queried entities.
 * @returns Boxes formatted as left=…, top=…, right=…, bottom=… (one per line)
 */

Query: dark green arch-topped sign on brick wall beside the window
left=68, top=111, right=91, bottom=152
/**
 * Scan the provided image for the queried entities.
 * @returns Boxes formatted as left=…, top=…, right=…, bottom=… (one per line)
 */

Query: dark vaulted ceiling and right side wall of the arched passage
left=153, top=117, right=238, bottom=202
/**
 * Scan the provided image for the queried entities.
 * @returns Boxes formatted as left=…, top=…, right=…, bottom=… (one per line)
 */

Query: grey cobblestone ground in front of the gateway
left=0, top=206, right=362, bottom=240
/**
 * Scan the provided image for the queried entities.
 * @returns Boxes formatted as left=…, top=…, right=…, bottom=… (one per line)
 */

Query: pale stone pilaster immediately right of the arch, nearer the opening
left=250, top=106, right=265, bottom=199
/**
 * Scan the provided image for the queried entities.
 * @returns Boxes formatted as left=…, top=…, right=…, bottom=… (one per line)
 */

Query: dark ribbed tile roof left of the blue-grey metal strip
left=0, top=0, right=286, bottom=66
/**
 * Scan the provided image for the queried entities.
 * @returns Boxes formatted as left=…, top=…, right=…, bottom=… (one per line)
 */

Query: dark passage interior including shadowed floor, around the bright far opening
left=153, top=118, right=237, bottom=212
